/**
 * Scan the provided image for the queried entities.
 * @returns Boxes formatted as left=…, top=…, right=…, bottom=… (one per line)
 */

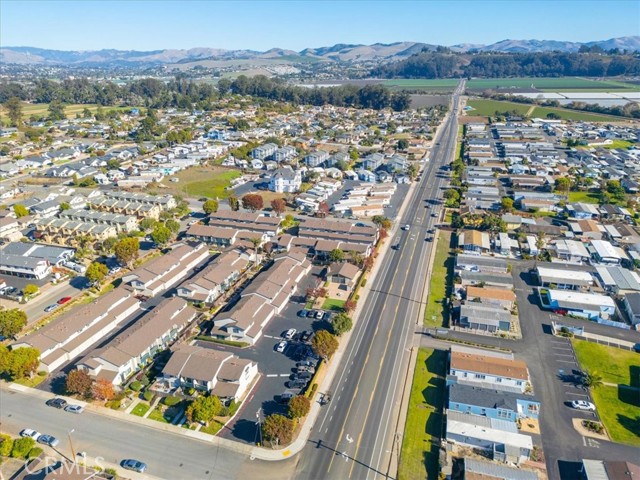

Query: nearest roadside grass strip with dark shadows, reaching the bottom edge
left=398, top=348, right=447, bottom=480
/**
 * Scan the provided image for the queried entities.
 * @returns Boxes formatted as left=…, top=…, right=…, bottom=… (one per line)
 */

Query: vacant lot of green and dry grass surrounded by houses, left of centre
left=162, top=167, right=240, bottom=199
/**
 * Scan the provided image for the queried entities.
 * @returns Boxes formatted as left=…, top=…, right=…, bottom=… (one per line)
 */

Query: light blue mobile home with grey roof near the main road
left=449, top=383, right=540, bottom=422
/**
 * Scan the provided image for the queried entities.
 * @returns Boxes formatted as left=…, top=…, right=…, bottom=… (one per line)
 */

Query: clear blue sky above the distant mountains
left=0, top=0, right=640, bottom=50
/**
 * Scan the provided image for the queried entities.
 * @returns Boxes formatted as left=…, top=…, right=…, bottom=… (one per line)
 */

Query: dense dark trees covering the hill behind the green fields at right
left=372, top=51, right=640, bottom=78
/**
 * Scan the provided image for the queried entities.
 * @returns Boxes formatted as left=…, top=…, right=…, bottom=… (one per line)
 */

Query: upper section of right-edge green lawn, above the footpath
left=573, top=340, right=640, bottom=388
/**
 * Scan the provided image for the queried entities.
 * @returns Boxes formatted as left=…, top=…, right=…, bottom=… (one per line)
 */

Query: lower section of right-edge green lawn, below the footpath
left=592, top=386, right=640, bottom=447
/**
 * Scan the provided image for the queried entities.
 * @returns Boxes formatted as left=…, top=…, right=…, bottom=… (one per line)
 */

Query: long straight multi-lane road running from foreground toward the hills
left=295, top=80, right=464, bottom=480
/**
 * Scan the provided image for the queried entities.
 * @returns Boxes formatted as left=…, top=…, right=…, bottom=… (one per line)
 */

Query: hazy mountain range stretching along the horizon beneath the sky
left=0, top=36, right=640, bottom=67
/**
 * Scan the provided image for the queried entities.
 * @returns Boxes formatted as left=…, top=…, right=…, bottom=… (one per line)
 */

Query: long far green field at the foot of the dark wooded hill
left=466, top=77, right=640, bottom=92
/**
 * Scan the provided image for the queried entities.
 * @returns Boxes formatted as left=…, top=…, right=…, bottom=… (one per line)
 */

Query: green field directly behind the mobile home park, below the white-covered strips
left=467, top=98, right=629, bottom=122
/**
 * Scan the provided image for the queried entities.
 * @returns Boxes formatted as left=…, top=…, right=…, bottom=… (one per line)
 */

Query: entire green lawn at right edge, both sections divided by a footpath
left=573, top=340, right=640, bottom=446
